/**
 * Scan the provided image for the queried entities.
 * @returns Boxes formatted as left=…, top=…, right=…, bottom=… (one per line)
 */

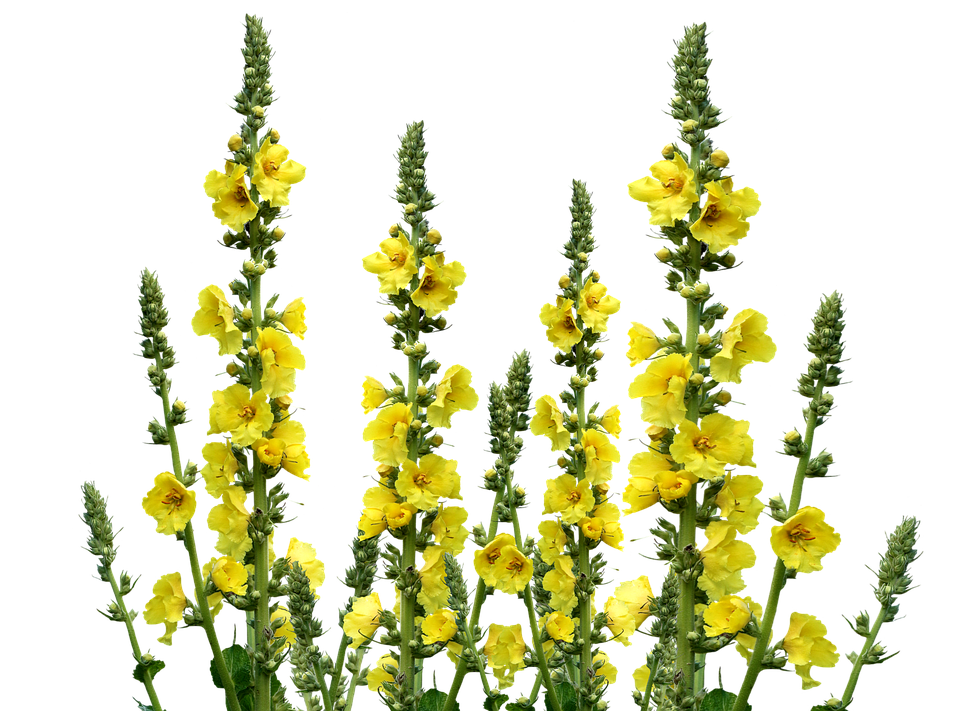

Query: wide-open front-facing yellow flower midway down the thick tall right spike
left=670, top=412, right=756, bottom=479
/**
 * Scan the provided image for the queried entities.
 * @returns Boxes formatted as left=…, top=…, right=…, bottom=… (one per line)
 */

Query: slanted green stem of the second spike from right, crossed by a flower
left=733, top=379, right=828, bottom=711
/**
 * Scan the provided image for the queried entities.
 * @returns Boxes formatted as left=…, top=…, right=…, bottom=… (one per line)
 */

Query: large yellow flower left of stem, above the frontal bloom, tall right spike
left=627, top=353, right=693, bottom=428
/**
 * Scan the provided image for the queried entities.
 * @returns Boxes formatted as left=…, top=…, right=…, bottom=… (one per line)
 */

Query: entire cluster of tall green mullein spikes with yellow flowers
left=81, top=15, right=920, bottom=711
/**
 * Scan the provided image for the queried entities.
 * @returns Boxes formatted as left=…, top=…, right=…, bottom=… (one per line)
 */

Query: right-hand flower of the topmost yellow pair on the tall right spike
left=688, top=178, right=762, bottom=254
